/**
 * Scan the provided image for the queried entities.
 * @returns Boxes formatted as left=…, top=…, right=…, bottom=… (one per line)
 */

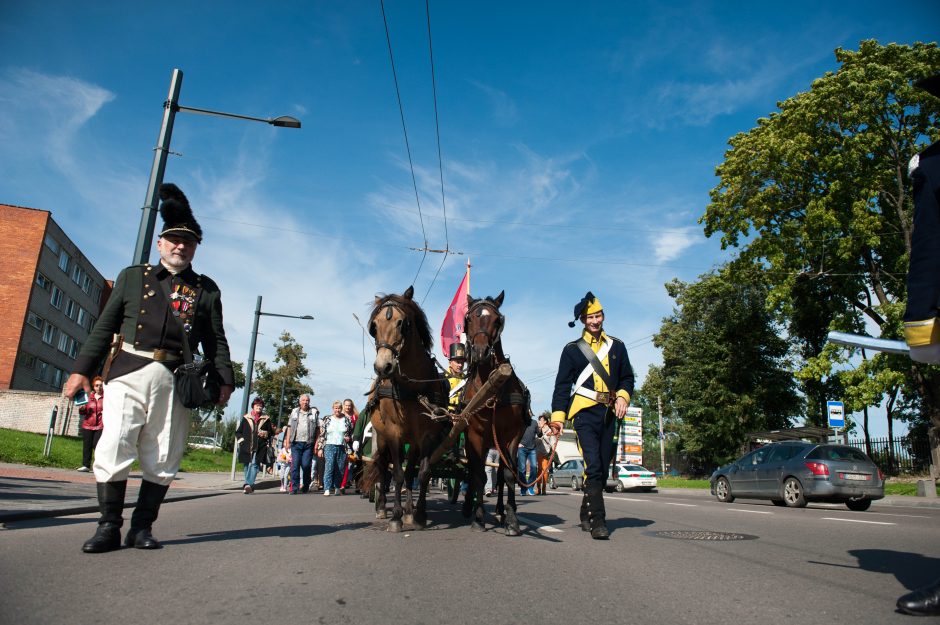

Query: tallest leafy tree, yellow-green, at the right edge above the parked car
left=702, top=41, right=940, bottom=458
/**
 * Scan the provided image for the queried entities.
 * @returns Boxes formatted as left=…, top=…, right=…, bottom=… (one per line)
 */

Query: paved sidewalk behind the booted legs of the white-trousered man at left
left=0, top=463, right=280, bottom=524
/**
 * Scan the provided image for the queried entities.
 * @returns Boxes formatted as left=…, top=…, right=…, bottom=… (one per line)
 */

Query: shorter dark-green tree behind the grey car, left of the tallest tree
left=641, top=268, right=799, bottom=468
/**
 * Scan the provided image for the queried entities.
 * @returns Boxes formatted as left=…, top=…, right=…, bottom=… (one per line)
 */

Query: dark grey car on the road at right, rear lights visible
left=711, top=441, right=885, bottom=510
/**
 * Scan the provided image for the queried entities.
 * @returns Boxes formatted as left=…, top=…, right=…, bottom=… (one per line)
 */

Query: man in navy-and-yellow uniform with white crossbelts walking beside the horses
left=552, top=291, right=634, bottom=540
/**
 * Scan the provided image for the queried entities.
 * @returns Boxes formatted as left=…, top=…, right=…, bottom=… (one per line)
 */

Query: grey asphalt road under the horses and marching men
left=0, top=488, right=940, bottom=625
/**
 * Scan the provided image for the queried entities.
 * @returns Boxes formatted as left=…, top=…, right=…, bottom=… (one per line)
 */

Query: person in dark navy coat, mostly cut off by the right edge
left=897, top=74, right=940, bottom=616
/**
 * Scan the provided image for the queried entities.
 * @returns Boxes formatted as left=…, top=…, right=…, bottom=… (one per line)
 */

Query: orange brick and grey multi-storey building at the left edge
left=0, top=204, right=112, bottom=392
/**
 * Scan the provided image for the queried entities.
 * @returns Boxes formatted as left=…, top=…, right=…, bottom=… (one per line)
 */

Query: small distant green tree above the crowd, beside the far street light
left=251, top=331, right=314, bottom=425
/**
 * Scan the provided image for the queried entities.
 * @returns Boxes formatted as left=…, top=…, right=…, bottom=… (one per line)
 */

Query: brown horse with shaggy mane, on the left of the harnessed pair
left=362, top=287, right=448, bottom=532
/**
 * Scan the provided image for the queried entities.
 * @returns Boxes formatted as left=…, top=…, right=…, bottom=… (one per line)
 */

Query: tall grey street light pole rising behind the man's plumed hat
left=132, top=69, right=300, bottom=265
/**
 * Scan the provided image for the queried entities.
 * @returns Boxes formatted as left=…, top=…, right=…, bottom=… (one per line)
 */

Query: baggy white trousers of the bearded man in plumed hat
left=94, top=362, right=190, bottom=486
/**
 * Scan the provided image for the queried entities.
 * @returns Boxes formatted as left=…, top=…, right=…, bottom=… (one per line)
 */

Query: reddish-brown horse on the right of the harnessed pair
left=463, top=292, right=531, bottom=536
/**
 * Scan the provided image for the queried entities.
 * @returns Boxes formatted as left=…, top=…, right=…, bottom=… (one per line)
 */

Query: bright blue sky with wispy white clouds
left=0, top=0, right=940, bottom=435
